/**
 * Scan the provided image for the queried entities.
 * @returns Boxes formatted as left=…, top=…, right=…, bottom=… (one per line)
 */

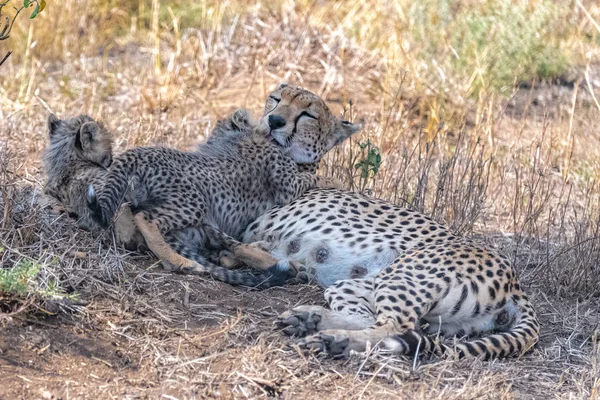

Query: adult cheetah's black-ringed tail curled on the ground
left=383, top=295, right=540, bottom=360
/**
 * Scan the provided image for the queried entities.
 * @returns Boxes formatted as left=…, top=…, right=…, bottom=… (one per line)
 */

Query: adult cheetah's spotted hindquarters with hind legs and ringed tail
left=277, top=239, right=539, bottom=359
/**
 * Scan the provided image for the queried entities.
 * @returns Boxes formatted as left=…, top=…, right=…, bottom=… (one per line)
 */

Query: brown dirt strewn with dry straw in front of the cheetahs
left=0, top=216, right=600, bottom=399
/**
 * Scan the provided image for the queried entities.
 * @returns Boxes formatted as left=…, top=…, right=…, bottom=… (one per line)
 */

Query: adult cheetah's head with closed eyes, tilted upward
left=257, top=84, right=362, bottom=163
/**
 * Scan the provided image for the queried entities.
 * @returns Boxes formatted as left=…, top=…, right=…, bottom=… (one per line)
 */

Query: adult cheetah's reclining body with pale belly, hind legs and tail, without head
left=243, top=189, right=539, bottom=358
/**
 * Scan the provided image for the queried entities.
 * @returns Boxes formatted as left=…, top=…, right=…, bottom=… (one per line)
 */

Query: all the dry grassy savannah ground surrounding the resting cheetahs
left=0, top=0, right=600, bottom=399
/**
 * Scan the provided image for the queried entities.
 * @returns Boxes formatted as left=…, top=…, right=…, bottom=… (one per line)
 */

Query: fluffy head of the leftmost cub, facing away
left=47, top=114, right=112, bottom=168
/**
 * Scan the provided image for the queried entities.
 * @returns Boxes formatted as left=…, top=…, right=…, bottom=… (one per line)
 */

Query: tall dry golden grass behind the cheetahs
left=0, top=0, right=600, bottom=297
